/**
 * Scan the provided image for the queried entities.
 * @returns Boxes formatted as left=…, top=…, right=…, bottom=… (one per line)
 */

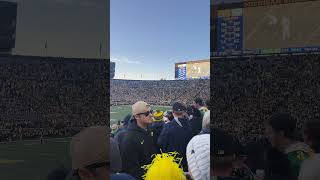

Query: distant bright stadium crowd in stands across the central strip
left=110, top=79, right=210, bottom=106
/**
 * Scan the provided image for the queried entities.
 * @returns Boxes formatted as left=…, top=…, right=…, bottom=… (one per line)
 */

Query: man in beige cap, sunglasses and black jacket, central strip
left=120, top=101, right=156, bottom=179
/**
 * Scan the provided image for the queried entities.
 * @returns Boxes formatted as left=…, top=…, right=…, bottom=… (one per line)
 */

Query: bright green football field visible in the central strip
left=110, top=105, right=171, bottom=125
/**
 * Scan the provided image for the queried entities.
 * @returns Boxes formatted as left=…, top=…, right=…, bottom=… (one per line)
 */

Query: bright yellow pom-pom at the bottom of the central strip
left=142, top=152, right=186, bottom=180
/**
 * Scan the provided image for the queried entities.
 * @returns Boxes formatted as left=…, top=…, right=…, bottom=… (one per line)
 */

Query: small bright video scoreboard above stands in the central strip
left=175, top=60, right=210, bottom=80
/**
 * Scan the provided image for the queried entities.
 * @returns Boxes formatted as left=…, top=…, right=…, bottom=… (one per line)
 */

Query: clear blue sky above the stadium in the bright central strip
left=110, top=0, right=210, bottom=79
